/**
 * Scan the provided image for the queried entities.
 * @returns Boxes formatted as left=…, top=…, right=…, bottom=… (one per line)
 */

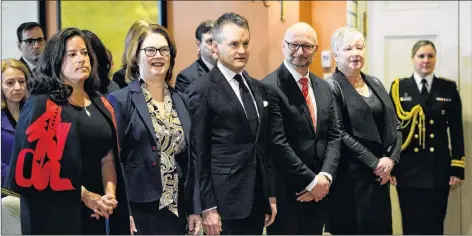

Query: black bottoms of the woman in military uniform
left=397, top=187, right=449, bottom=235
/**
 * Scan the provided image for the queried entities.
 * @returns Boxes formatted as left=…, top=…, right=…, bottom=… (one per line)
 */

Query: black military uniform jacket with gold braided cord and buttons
left=390, top=76, right=465, bottom=189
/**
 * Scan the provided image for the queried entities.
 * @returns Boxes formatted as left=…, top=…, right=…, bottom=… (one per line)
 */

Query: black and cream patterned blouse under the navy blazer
left=141, top=81, right=185, bottom=216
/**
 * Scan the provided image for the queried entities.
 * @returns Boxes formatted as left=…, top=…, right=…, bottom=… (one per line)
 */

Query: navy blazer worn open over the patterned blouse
left=108, top=80, right=201, bottom=214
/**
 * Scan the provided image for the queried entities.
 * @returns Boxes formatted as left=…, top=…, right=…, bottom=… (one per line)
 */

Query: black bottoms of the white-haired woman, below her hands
left=329, top=177, right=392, bottom=235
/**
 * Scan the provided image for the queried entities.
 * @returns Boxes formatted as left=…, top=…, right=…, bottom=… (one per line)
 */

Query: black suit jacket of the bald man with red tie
left=263, top=63, right=341, bottom=194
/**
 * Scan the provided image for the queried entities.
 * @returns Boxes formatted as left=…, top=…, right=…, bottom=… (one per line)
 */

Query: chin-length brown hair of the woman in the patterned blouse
left=125, top=24, right=177, bottom=83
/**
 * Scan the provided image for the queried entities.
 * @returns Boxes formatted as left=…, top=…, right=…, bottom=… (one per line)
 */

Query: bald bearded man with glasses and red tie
left=263, top=22, right=341, bottom=235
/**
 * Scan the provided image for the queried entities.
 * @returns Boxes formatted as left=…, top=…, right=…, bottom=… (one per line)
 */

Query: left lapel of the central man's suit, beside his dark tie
left=211, top=67, right=251, bottom=130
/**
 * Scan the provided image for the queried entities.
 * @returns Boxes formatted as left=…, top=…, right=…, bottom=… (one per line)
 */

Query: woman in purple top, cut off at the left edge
left=2, top=59, right=30, bottom=186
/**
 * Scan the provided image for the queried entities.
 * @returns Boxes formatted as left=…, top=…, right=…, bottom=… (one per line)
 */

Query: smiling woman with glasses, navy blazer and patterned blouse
left=108, top=24, right=201, bottom=235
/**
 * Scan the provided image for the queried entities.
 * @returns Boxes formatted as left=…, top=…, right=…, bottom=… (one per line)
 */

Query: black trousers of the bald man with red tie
left=267, top=196, right=328, bottom=235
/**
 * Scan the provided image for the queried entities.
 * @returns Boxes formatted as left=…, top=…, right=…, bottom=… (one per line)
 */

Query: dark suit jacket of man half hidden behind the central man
left=175, top=57, right=209, bottom=93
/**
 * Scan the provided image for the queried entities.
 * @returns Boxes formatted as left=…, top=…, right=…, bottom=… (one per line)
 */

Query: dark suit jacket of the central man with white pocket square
left=189, top=67, right=274, bottom=219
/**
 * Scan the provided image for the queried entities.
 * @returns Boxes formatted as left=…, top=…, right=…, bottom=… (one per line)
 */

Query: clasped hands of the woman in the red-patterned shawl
left=82, top=187, right=118, bottom=219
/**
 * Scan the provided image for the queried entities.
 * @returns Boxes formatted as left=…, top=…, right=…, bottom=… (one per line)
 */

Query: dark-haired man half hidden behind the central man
left=175, top=20, right=217, bottom=93
